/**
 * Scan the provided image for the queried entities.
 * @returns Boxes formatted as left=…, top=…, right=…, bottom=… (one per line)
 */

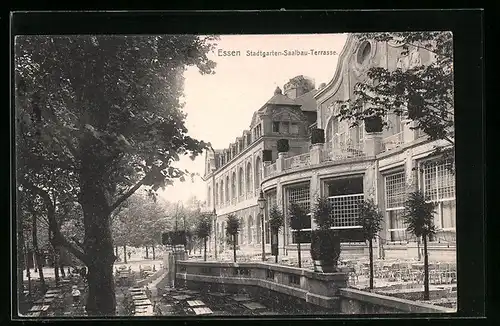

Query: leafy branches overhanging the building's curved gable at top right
left=338, top=32, right=455, bottom=166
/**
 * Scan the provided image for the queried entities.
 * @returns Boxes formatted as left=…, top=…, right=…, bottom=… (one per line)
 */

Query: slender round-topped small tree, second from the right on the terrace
left=359, top=199, right=384, bottom=290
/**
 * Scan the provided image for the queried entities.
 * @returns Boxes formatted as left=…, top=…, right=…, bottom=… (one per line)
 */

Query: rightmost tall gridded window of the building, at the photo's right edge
left=423, top=159, right=456, bottom=241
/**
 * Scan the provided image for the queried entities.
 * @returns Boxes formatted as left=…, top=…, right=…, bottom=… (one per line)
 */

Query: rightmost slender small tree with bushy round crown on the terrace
left=403, top=190, right=436, bottom=300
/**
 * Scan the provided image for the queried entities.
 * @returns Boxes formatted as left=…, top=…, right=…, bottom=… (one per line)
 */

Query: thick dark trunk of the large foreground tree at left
left=80, top=173, right=116, bottom=316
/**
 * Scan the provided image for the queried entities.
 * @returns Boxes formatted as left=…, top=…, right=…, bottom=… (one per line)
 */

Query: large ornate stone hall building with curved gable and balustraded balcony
left=204, top=35, right=456, bottom=260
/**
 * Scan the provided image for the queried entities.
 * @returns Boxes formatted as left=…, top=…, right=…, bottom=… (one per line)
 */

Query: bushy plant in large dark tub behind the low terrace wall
left=311, top=197, right=340, bottom=273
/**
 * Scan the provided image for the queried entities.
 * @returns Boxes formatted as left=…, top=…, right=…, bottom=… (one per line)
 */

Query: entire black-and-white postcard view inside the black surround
left=12, top=17, right=459, bottom=320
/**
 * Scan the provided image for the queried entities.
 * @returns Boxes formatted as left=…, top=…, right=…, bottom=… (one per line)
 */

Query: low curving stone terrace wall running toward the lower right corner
left=176, top=261, right=453, bottom=314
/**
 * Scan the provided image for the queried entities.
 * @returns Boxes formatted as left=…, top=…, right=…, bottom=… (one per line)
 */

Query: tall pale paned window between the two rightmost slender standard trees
left=385, top=171, right=407, bottom=241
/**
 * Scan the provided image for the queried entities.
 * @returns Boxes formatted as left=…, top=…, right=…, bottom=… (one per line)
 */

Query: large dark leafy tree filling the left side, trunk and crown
left=15, top=35, right=215, bottom=315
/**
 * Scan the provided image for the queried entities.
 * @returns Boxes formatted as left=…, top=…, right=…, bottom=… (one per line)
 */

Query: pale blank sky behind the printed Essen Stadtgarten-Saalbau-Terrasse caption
left=159, top=34, right=347, bottom=206
